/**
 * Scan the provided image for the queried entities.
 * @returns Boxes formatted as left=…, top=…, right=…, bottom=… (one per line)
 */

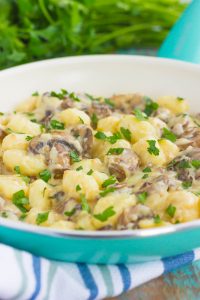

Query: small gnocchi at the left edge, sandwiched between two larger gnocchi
left=2, top=133, right=29, bottom=151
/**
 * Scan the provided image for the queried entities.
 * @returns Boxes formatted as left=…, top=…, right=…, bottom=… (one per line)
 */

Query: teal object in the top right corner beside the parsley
left=158, top=0, right=200, bottom=64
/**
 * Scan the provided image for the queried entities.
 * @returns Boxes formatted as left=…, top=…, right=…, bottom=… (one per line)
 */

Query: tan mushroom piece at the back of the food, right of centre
left=111, top=94, right=145, bottom=114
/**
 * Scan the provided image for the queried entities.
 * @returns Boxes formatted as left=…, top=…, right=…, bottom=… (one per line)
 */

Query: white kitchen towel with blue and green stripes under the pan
left=0, top=244, right=200, bottom=300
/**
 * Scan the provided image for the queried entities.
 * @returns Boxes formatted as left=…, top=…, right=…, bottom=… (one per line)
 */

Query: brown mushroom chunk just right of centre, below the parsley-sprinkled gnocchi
left=106, top=149, right=139, bottom=181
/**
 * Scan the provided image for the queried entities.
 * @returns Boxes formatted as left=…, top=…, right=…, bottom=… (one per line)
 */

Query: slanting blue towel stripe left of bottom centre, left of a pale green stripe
left=77, top=263, right=98, bottom=300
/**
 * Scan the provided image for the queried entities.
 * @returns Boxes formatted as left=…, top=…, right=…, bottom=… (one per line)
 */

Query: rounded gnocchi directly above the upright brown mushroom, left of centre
left=59, top=108, right=90, bottom=126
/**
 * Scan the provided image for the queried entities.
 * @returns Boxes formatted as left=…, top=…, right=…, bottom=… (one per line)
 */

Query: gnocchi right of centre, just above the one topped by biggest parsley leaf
left=118, top=115, right=157, bottom=143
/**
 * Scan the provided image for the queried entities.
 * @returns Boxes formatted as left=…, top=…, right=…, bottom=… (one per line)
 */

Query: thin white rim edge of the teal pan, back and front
left=0, top=54, right=200, bottom=239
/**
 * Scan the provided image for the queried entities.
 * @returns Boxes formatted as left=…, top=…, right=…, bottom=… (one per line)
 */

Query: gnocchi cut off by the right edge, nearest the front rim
left=166, top=191, right=200, bottom=223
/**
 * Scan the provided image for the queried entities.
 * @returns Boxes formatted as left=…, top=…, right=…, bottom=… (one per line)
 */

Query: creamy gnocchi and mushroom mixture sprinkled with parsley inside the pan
left=0, top=89, right=200, bottom=230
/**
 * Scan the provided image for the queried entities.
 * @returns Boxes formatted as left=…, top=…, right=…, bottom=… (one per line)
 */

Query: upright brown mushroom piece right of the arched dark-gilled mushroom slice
left=71, top=125, right=93, bottom=158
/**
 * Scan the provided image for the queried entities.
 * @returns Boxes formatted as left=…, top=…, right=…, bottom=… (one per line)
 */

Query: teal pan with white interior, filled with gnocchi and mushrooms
left=0, top=55, right=200, bottom=264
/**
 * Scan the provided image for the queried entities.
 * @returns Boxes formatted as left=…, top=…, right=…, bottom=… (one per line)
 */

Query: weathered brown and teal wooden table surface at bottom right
left=107, top=261, right=200, bottom=300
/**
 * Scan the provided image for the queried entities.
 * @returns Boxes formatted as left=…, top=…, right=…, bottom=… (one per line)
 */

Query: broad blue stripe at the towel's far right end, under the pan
left=162, top=251, right=194, bottom=273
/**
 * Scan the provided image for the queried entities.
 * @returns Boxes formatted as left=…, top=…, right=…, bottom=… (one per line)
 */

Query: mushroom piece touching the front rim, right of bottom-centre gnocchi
left=116, top=204, right=153, bottom=230
